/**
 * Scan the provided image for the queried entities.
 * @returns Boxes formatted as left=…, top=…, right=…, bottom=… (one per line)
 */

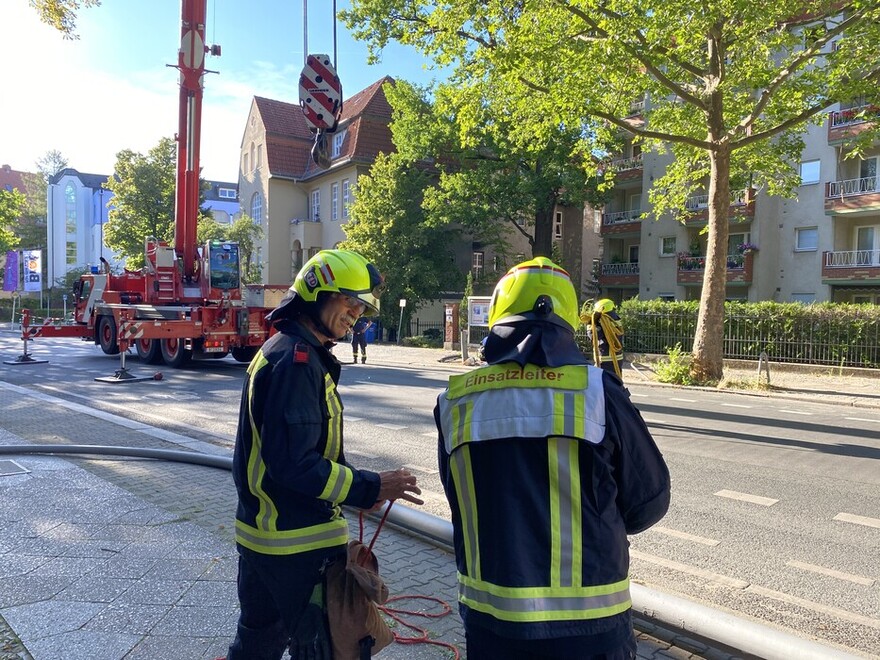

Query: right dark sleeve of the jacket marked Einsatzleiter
left=602, top=373, right=671, bottom=534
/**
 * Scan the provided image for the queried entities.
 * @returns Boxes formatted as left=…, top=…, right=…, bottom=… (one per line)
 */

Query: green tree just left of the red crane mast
left=104, top=138, right=209, bottom=269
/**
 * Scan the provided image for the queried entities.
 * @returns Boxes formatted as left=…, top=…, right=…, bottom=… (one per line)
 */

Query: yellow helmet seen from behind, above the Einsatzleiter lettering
left=489, top=257, right=578, bottom=332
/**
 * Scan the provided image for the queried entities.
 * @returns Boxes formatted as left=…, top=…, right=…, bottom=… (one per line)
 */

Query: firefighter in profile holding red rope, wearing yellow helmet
left=228, top=250, right=422, bottom=660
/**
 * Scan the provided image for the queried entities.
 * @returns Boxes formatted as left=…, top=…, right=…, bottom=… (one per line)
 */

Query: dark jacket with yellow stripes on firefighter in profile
left=233, top=320, right=379, bottom=556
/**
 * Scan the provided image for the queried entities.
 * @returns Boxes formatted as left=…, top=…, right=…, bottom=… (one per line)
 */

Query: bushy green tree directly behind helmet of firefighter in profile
left=340, top=154, right=462, bottom=328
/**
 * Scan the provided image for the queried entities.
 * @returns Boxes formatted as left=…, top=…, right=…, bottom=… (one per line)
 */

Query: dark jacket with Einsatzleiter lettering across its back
left=434, top=358, right=670, bottom=639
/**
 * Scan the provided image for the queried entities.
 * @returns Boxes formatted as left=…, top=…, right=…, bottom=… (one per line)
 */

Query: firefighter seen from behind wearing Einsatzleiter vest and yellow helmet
left=434, top=257, right=670, bottom=660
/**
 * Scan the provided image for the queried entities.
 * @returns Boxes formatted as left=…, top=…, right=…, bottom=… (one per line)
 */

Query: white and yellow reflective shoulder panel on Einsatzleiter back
left=438, top=365, right=605, bottom=454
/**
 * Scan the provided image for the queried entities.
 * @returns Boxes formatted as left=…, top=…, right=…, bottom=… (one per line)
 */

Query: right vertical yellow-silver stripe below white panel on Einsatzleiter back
left=548, top=438, right=583, bottom=587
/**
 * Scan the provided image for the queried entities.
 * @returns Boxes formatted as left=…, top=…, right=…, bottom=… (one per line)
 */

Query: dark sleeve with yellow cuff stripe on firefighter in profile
left=254, top=356, right=380, bottom=508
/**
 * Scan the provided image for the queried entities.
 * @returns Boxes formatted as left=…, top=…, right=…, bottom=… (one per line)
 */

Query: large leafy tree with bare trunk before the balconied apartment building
left=342, top=0, right=880, bottom=382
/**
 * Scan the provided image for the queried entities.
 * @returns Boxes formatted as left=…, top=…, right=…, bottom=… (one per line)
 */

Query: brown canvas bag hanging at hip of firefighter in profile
left=326, top=518, right=394, bottom=660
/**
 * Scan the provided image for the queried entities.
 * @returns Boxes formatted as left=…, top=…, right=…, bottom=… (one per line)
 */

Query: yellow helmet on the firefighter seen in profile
left=290, top=250, right=383, bottom=316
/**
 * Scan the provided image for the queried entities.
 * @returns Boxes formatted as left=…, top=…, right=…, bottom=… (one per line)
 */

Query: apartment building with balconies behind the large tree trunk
left=598, top=102, right=880, bottom=304
